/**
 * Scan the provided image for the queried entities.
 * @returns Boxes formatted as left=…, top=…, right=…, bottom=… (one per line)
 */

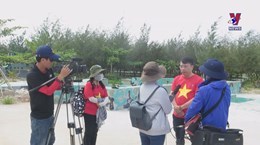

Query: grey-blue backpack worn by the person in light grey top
left=129, top=86, right=161, bottom=131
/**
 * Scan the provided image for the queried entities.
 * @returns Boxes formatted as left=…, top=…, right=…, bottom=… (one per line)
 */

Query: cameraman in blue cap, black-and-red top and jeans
left=27, top=45, right=71, bottom=145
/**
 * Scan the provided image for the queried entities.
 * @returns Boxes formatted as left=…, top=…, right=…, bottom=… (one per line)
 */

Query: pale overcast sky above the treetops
left=0, top=0, right=260, bottom=42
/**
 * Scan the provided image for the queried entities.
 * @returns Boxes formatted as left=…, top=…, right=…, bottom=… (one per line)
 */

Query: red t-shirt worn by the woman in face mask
left=84, top=82, right=108, bottom=115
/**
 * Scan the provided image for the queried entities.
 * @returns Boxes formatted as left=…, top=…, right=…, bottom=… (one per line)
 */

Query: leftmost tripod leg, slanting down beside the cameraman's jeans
left=45, top=92, right=64, bottom=145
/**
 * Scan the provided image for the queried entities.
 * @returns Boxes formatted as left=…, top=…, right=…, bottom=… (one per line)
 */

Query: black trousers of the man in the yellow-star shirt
left=172, top=115, right=185, bottom=145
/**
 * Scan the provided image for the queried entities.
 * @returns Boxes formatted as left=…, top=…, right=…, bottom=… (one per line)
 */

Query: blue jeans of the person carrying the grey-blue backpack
left=140, top=132, right=165, bottom=145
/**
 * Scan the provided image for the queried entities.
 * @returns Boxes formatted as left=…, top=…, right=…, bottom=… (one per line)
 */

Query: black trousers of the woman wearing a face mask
left=84, top=114, right=98, bottom=145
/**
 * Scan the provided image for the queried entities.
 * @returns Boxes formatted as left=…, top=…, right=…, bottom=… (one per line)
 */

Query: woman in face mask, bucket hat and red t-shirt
left=84, top=65, right=109, bottom=145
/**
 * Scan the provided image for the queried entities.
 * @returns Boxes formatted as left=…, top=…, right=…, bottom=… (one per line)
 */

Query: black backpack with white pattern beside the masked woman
left=71, top=87, right=86, bottom=117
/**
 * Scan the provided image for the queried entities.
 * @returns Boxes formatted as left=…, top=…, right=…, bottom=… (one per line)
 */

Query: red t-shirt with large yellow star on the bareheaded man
left=171, top=74, right=203, bottom=118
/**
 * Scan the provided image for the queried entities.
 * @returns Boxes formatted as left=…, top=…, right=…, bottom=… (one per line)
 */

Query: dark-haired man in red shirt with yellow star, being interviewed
left=170, top=57, right=203, bottom=145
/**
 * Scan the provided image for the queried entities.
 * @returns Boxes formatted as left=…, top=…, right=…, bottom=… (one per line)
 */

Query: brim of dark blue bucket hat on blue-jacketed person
left=199, top=65, right=228, bottom=80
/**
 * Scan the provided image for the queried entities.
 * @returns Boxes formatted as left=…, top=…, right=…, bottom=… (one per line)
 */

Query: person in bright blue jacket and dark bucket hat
left=185, top=59, right=231, bottom=132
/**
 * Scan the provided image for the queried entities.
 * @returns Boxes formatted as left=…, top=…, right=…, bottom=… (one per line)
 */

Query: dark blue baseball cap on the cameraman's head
left=36, top=45, right=60, bottom=61
